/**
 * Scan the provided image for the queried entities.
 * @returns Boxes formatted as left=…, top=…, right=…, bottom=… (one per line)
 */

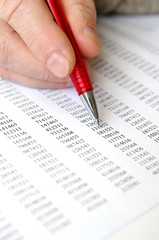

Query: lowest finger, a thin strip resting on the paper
left=0, top=67, right=73, bottom=89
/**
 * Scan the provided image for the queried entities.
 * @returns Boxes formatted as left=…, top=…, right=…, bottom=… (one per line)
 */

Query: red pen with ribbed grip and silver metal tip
left=46, top=0, right=99, bottom=125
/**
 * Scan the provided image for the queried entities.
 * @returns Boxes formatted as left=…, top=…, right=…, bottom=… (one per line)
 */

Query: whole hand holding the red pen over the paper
left=0, top=0, right=100, bottom=88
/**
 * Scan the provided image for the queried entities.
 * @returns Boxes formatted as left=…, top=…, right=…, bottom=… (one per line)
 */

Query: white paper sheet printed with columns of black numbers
left=0, top=16, right=159, bottom=240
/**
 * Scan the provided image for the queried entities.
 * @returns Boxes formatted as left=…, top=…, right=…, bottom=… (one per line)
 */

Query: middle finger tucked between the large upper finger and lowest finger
left=0, top=19, right=70, bottom=82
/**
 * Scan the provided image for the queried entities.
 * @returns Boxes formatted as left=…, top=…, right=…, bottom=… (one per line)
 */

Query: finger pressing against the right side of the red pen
left=61, top=0, right=101, bottom=58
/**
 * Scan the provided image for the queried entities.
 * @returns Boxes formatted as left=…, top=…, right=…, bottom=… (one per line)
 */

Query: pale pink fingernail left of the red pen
left=47, top=52, right=69, bottom=78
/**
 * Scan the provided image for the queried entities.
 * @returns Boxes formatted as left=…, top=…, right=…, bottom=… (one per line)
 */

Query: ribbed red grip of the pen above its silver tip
left=70, top=62, right=93, bottom=95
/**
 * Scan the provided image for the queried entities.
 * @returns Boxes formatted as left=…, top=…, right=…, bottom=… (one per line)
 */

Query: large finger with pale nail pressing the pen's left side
left=0, top=0, right=75, bottom=78
